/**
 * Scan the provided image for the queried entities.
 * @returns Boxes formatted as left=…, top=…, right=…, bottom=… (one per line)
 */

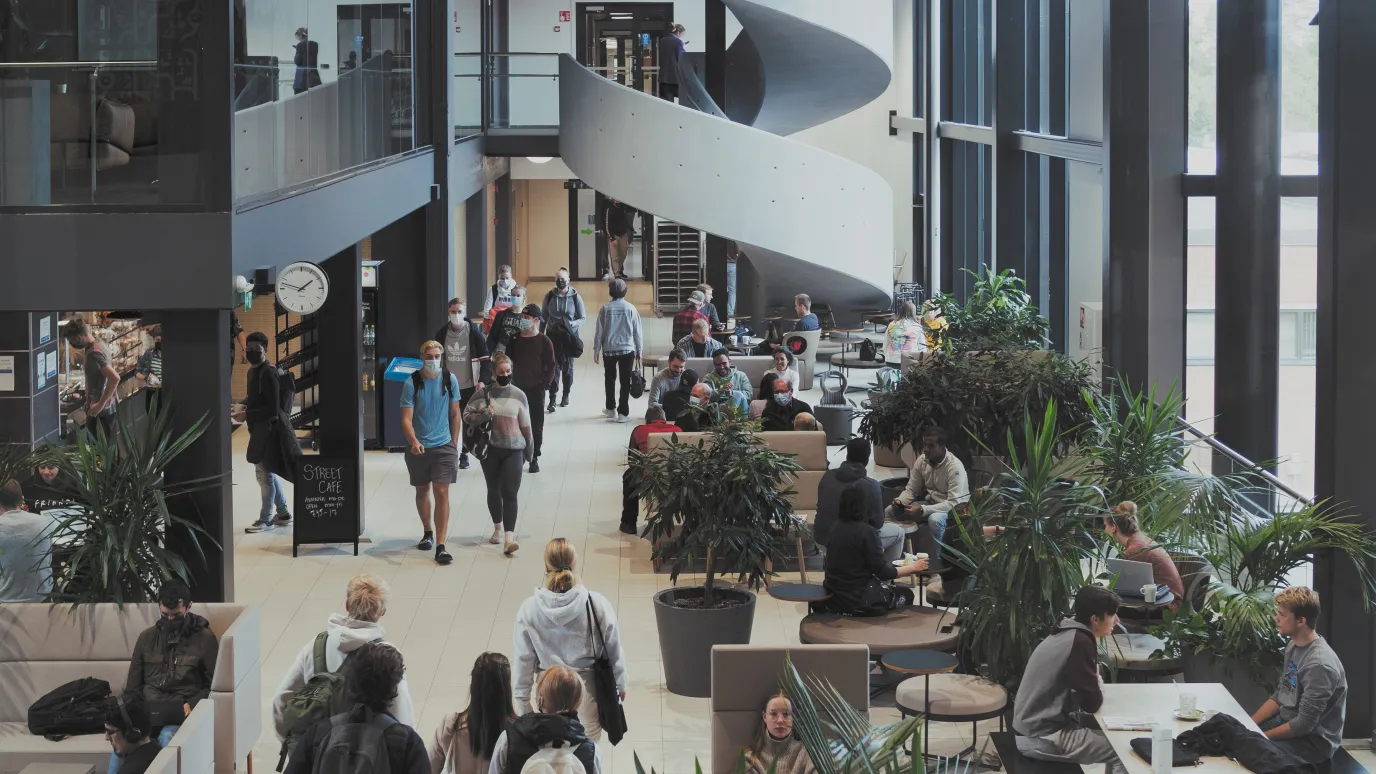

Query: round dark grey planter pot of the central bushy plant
left=655, top=585, right=755, bottom=698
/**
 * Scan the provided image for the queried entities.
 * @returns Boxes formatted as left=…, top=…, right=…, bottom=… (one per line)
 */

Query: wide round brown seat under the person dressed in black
left=798, top=606, right=960, bottom=656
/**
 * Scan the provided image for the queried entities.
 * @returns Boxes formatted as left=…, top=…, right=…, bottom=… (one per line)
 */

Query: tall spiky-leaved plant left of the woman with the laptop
left=943, top=401, right=1104, bottom=689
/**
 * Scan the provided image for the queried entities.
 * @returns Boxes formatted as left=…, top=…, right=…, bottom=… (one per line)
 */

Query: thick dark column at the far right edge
left=1309, top=0, right=1376, bottom=737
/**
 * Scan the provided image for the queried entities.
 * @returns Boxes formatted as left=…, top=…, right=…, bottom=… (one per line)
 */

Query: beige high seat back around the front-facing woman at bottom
left=711, top=645, right=870, bottom=774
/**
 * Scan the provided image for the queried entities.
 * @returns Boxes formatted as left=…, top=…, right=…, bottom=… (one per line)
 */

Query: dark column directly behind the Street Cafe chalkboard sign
left=316, top=245, right=366, bottom=533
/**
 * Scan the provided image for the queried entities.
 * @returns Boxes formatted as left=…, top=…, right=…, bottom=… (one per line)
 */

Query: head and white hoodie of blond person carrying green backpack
left=272, top=576, right=416, bottom=741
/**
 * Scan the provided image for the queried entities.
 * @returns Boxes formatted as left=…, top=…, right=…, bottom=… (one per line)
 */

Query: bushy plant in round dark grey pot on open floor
left=632, top=417, right=804, bottom=697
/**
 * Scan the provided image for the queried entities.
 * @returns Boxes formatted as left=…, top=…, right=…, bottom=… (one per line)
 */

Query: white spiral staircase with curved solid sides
left=559, top=0, right=893, bottom=313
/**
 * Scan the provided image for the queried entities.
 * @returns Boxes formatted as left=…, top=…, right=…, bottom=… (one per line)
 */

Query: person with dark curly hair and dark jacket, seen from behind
left=286, top=642, right=431, bottom=774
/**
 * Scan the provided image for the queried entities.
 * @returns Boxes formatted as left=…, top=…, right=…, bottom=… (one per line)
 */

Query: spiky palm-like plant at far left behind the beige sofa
left=50, top=404, right=224, bottom=607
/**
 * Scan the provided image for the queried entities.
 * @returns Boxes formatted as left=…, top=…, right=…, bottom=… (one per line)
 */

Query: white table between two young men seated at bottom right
left=1083, top=683, right=1260, bottom=774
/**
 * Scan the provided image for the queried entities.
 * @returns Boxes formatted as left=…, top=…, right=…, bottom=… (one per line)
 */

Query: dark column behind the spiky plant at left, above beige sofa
left=158, top=308, right=235, bottom=602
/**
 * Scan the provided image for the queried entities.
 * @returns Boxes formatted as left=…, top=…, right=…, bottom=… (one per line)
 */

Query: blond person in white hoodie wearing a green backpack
left=272, top=576, right=416, bottom=756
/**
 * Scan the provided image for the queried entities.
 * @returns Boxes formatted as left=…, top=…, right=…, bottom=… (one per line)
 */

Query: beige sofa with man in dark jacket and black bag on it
left=0, top=603, right=263, bottom=774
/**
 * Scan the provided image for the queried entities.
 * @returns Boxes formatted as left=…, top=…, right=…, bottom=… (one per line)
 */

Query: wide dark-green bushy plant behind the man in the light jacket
left=860, top=350, right=1094, bottom=461
